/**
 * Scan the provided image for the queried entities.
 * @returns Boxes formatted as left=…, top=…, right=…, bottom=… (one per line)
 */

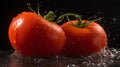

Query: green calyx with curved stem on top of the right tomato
left=57, top=13, right=102, bottom=28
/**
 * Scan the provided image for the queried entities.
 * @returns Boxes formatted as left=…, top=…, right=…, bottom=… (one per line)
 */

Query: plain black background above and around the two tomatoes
left=0, top=0, right=120, bottom=50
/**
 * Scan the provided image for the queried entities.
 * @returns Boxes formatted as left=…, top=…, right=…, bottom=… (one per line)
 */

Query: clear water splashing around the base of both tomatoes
left=9, top=48, right=120, bottom=67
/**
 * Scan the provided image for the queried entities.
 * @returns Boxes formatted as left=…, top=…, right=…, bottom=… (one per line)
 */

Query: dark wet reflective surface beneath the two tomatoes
left=0, top=49, right=120, bottom=67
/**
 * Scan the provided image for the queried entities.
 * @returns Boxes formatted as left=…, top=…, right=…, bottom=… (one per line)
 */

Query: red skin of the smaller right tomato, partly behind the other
left=61, top=20, right=107, bottom=56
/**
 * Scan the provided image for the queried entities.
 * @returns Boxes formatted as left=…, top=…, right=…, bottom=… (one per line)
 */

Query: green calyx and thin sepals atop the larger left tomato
left=27, top=3, right=56, bottom=22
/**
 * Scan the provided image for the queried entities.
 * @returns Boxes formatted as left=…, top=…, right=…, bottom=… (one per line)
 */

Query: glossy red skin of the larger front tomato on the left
left=8, top=12, right=66, bottom=57
